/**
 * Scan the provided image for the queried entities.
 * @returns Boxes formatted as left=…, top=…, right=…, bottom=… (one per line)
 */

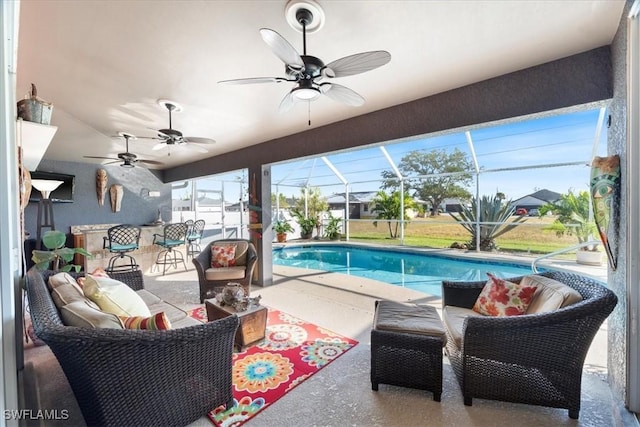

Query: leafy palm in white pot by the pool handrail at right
left=539, top=190, right=602, bottom=265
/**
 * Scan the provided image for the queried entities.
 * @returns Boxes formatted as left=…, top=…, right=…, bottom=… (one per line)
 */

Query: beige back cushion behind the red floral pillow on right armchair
left=520, top=274, right=582, bottom=314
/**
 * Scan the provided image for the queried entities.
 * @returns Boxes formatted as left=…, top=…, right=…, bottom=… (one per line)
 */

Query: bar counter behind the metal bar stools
left=71, top=224, right=169, bottom=272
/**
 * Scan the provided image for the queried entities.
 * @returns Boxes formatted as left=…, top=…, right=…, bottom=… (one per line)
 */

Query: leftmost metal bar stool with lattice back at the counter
left=102, top=224, right=140, bottom=273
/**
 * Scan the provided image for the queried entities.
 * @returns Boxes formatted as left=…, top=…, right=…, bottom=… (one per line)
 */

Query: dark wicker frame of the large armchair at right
left=442, top=272, right=618, bottom=419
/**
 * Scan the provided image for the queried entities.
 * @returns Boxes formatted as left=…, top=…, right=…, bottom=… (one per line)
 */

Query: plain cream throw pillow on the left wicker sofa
left=82, top=274, right=151, bottom=317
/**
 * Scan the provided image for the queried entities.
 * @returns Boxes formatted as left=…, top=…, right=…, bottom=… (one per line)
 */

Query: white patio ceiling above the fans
left=17, top=0, right=624, bottom=169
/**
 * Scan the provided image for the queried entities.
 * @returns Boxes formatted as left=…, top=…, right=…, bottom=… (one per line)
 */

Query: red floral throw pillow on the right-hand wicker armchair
left=473, top=273, right=536, bottom=316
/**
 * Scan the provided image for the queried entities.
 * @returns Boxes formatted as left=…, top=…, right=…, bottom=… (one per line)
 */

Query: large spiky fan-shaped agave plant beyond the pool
left=449, top=196, right=527, bottom=251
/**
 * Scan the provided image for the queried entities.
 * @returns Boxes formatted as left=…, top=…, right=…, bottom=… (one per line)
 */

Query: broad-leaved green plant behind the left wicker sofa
left=31, top=230, right=91, bottom=273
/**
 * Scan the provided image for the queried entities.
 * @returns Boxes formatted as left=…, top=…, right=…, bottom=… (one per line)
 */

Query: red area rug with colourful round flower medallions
left=189, top=307, right=358, bottom=427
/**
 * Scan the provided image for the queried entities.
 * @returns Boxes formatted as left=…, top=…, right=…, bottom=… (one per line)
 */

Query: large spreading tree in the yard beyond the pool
left=382, top=148, right=473, bottom=216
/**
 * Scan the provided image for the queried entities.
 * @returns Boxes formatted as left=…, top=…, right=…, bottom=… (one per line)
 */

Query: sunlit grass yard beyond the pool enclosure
left=349, top=215, right=578, bottom=257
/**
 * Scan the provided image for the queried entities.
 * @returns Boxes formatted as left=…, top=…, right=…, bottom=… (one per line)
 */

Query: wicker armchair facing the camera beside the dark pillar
left=192, top=239, right=258, bottom=303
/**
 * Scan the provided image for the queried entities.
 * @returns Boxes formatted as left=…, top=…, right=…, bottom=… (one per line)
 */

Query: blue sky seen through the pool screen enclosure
left=174, top=109, right=608, bottom=203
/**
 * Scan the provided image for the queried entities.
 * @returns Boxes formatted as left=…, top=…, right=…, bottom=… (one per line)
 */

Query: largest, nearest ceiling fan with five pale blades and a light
left=218, top=0, right=391, bottom=112
